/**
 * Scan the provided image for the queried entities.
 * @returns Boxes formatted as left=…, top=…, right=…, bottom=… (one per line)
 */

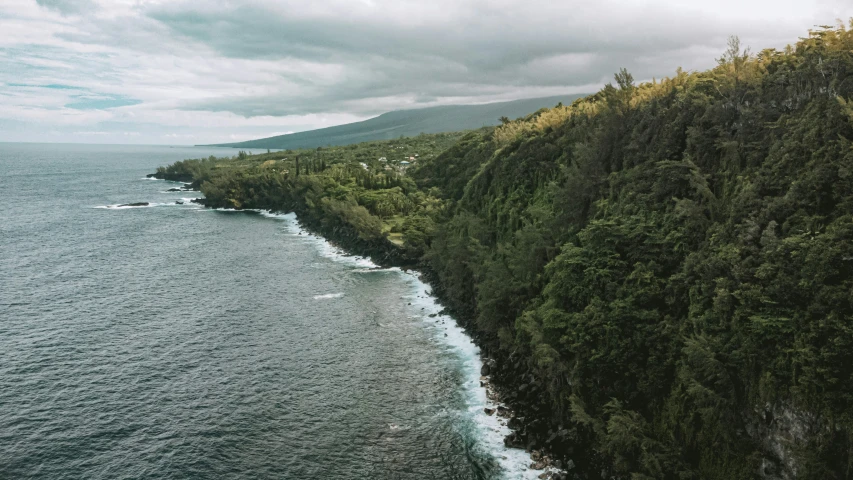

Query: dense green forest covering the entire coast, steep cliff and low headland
left=159, top=23, right=853, bottom=480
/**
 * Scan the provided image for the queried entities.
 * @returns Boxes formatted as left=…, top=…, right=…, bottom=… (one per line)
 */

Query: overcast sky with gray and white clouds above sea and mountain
left=0, top=0, right=853, bottom=144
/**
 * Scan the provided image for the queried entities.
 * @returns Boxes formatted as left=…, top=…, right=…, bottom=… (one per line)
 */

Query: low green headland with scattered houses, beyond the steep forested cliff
left=170, top=129, right=464, bottom=253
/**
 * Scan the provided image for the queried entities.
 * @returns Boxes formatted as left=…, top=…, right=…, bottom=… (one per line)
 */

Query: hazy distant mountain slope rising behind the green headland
left=206, top=94, right=586, bottom=149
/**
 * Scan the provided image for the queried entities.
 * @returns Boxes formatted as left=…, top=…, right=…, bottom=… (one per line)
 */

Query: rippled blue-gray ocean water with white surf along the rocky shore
left=0, top=143, right=526, bottom=479
